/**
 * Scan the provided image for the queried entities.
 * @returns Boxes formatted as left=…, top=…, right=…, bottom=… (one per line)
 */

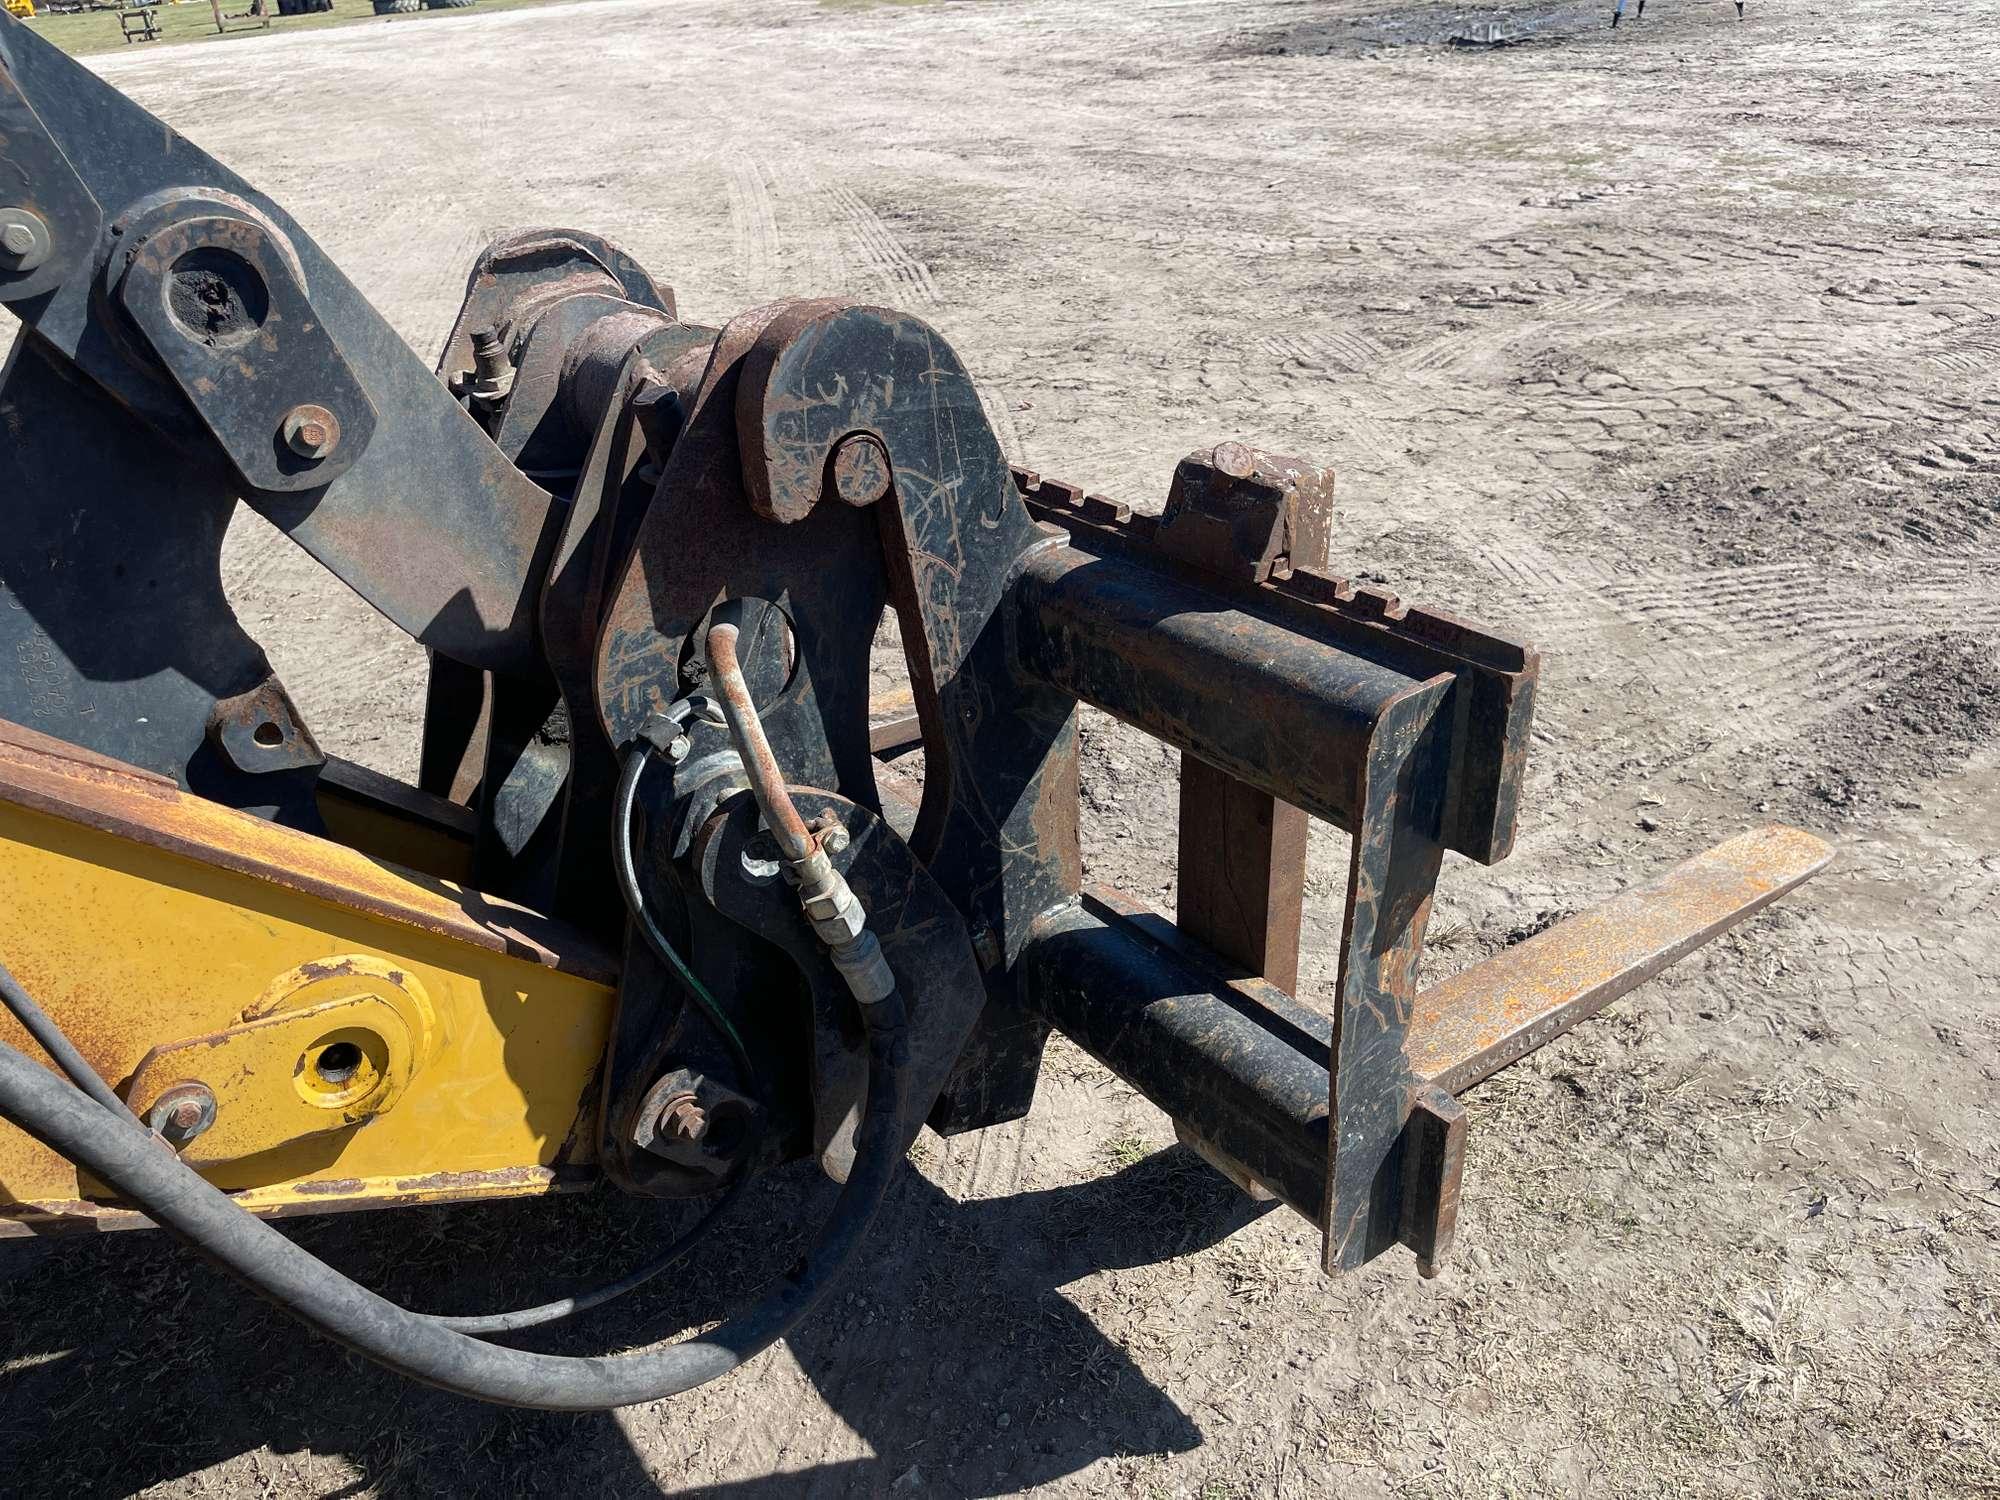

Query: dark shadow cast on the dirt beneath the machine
left=0, top=1148, right=1264, bottom=1498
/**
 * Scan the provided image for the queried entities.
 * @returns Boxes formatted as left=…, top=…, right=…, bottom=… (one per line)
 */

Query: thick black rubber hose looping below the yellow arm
left=0, top=994, right=910, bottom=1412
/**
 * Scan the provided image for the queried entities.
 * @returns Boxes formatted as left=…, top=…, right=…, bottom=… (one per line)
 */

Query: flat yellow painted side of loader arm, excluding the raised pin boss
left=0, top=792, right=612, bottom=1220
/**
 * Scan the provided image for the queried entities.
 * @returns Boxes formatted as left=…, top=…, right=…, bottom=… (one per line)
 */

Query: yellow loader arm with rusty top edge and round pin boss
left=0, top=726, right=616, bottom=1232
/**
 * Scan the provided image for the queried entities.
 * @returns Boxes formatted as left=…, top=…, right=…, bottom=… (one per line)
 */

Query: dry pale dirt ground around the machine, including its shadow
left=0, top=0, right=2000, bottom=1500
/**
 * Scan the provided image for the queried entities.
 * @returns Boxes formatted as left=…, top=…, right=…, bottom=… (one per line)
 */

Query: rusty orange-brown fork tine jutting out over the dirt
left=1410, top=828, right=1834, bottom=1094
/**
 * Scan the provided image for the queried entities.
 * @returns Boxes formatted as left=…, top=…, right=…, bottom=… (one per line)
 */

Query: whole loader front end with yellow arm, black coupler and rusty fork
left=0, top=8, right=1828, bottom=1402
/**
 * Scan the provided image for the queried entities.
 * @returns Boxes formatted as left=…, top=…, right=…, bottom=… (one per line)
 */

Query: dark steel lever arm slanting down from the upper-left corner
left=0, top=18, right=554, bottom=676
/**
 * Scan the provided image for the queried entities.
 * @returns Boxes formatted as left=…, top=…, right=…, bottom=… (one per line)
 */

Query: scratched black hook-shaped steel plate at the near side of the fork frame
left=736, top=302, right=1080, bottom=1130
